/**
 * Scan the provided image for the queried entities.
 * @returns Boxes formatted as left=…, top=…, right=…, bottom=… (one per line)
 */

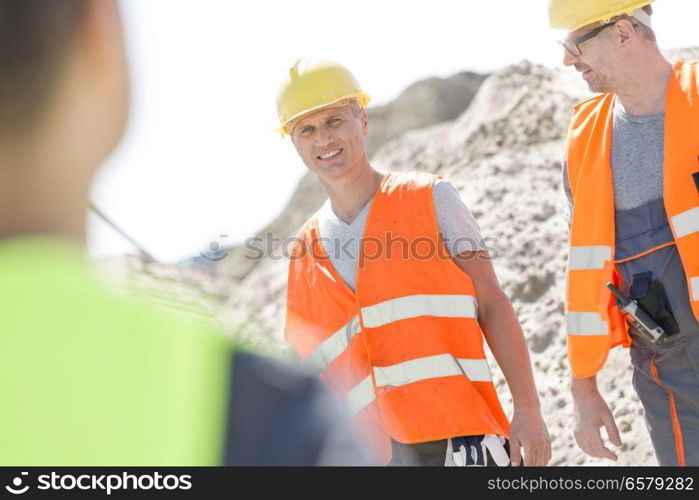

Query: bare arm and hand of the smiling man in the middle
left=454, top=251, right=551, bottom=465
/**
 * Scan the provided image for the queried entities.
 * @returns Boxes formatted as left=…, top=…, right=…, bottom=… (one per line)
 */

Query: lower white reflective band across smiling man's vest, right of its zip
left=374, top=354, right=492, bottom=387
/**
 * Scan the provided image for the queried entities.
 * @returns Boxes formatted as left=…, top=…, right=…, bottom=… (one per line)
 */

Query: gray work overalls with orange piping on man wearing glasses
left=615, top=199, right=699, bottom=465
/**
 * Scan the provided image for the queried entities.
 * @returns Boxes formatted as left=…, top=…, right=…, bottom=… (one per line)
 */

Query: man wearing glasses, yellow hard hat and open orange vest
left=549, top=0, right=699, bottom=465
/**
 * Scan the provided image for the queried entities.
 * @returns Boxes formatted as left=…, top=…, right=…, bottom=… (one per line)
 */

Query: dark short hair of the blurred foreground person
left=0, top=0, right=89, bottom=138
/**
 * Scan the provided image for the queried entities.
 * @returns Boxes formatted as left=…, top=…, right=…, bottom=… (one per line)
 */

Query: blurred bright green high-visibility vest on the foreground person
left=0, top=237, right=232, bottom=465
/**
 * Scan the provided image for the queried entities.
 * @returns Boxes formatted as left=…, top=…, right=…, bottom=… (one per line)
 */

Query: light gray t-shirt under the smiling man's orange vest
left=317, top=179, right=488, bottom=290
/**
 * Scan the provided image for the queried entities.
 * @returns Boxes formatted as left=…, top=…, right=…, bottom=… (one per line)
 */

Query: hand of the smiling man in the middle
left=510, top=408, right=551, bottom=466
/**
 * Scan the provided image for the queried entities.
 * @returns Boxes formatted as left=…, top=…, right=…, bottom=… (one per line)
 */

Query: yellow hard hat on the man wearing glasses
left=549, top=0, right=655, bottom=32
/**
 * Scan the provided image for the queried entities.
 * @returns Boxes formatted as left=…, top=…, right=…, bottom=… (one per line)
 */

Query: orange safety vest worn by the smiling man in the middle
left=285, top=172, right=509, bottom=463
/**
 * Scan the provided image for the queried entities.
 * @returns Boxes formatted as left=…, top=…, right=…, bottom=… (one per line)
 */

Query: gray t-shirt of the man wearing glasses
left=563, top=99, right=665, bottom=224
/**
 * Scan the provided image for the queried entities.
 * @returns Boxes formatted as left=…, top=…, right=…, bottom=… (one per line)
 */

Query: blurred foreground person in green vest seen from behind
left=0, top=0, right=368, bottom=465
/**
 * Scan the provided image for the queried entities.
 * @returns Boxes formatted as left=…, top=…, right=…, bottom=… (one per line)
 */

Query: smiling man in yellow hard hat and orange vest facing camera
left=277, top=61, right=551, bottom=465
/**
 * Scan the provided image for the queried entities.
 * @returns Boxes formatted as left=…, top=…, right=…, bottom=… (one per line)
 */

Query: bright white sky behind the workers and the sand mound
left=89, top=0, right=699, bottom=261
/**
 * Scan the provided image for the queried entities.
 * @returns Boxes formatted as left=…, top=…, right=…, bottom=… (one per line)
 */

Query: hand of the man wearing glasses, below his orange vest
left=573, top=384, right=621, bottom=461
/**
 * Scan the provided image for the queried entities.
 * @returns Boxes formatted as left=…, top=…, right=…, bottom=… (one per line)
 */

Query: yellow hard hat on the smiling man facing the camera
left=277, top=59, right=371, bottom=135
